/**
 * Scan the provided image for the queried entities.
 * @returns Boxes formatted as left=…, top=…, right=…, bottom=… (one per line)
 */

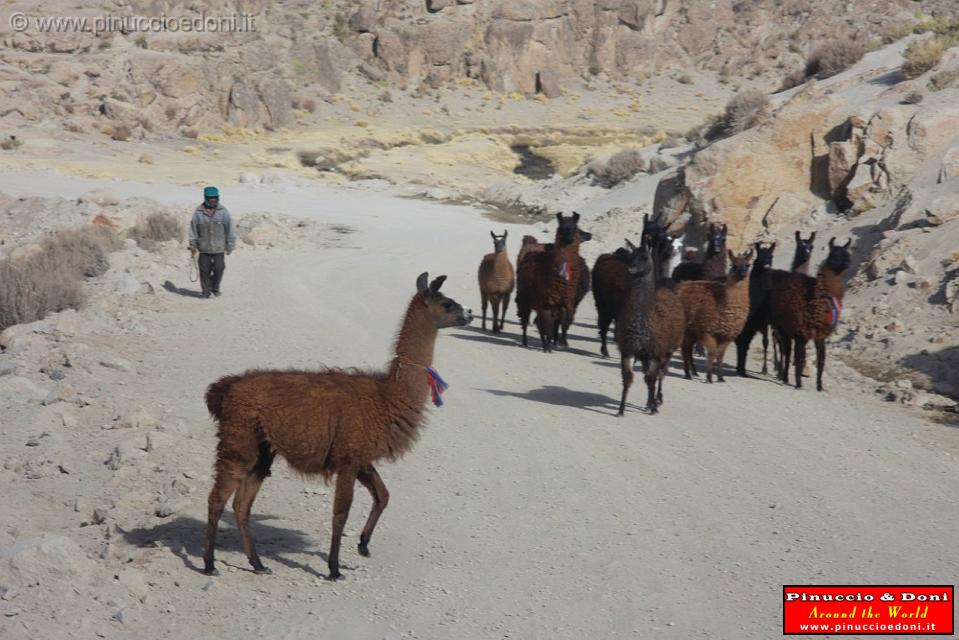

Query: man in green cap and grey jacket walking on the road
left=190, top=187, right=236, bottom=298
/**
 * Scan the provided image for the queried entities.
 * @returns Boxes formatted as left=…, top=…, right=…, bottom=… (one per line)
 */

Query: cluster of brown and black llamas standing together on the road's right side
left=479, top=213, right=852, bottom=415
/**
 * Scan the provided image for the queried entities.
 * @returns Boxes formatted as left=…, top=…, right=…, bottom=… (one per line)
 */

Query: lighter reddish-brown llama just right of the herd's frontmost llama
left=676, top=249, right=753, bottom=382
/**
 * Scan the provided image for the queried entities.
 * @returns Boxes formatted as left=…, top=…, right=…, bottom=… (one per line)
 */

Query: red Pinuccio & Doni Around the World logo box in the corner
left=783, top=585, right=955, bottom=636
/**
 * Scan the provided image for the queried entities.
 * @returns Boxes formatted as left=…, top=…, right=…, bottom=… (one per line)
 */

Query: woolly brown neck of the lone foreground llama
left=389, top=294, right=436, bottom=400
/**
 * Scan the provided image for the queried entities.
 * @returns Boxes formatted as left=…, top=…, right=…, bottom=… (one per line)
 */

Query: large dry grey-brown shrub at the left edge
left=0, top=226, right=123, bottom=331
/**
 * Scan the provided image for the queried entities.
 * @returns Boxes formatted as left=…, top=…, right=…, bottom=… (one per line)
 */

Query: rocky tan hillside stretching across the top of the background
left=0, top=0, right=956, bottom=140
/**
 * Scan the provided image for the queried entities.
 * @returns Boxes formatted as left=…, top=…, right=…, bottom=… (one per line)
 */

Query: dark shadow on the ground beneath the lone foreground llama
left=123, top=512, right=334, bottom=578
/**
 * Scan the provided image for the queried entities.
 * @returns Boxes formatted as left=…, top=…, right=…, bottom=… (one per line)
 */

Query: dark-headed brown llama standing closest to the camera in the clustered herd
left=616, top=235, right=686, bottom=416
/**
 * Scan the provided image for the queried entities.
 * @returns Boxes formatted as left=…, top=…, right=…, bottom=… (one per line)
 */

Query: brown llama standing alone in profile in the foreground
left=203, top=273, right=472, bottom=580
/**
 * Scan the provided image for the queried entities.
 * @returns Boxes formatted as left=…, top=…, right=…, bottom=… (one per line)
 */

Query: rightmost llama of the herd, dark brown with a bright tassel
left=770, top=238, right=852, bottom=391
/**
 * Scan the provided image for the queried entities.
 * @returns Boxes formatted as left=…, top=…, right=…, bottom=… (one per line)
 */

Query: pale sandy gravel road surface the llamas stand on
left=0, top=172, right=959, bottom=639
